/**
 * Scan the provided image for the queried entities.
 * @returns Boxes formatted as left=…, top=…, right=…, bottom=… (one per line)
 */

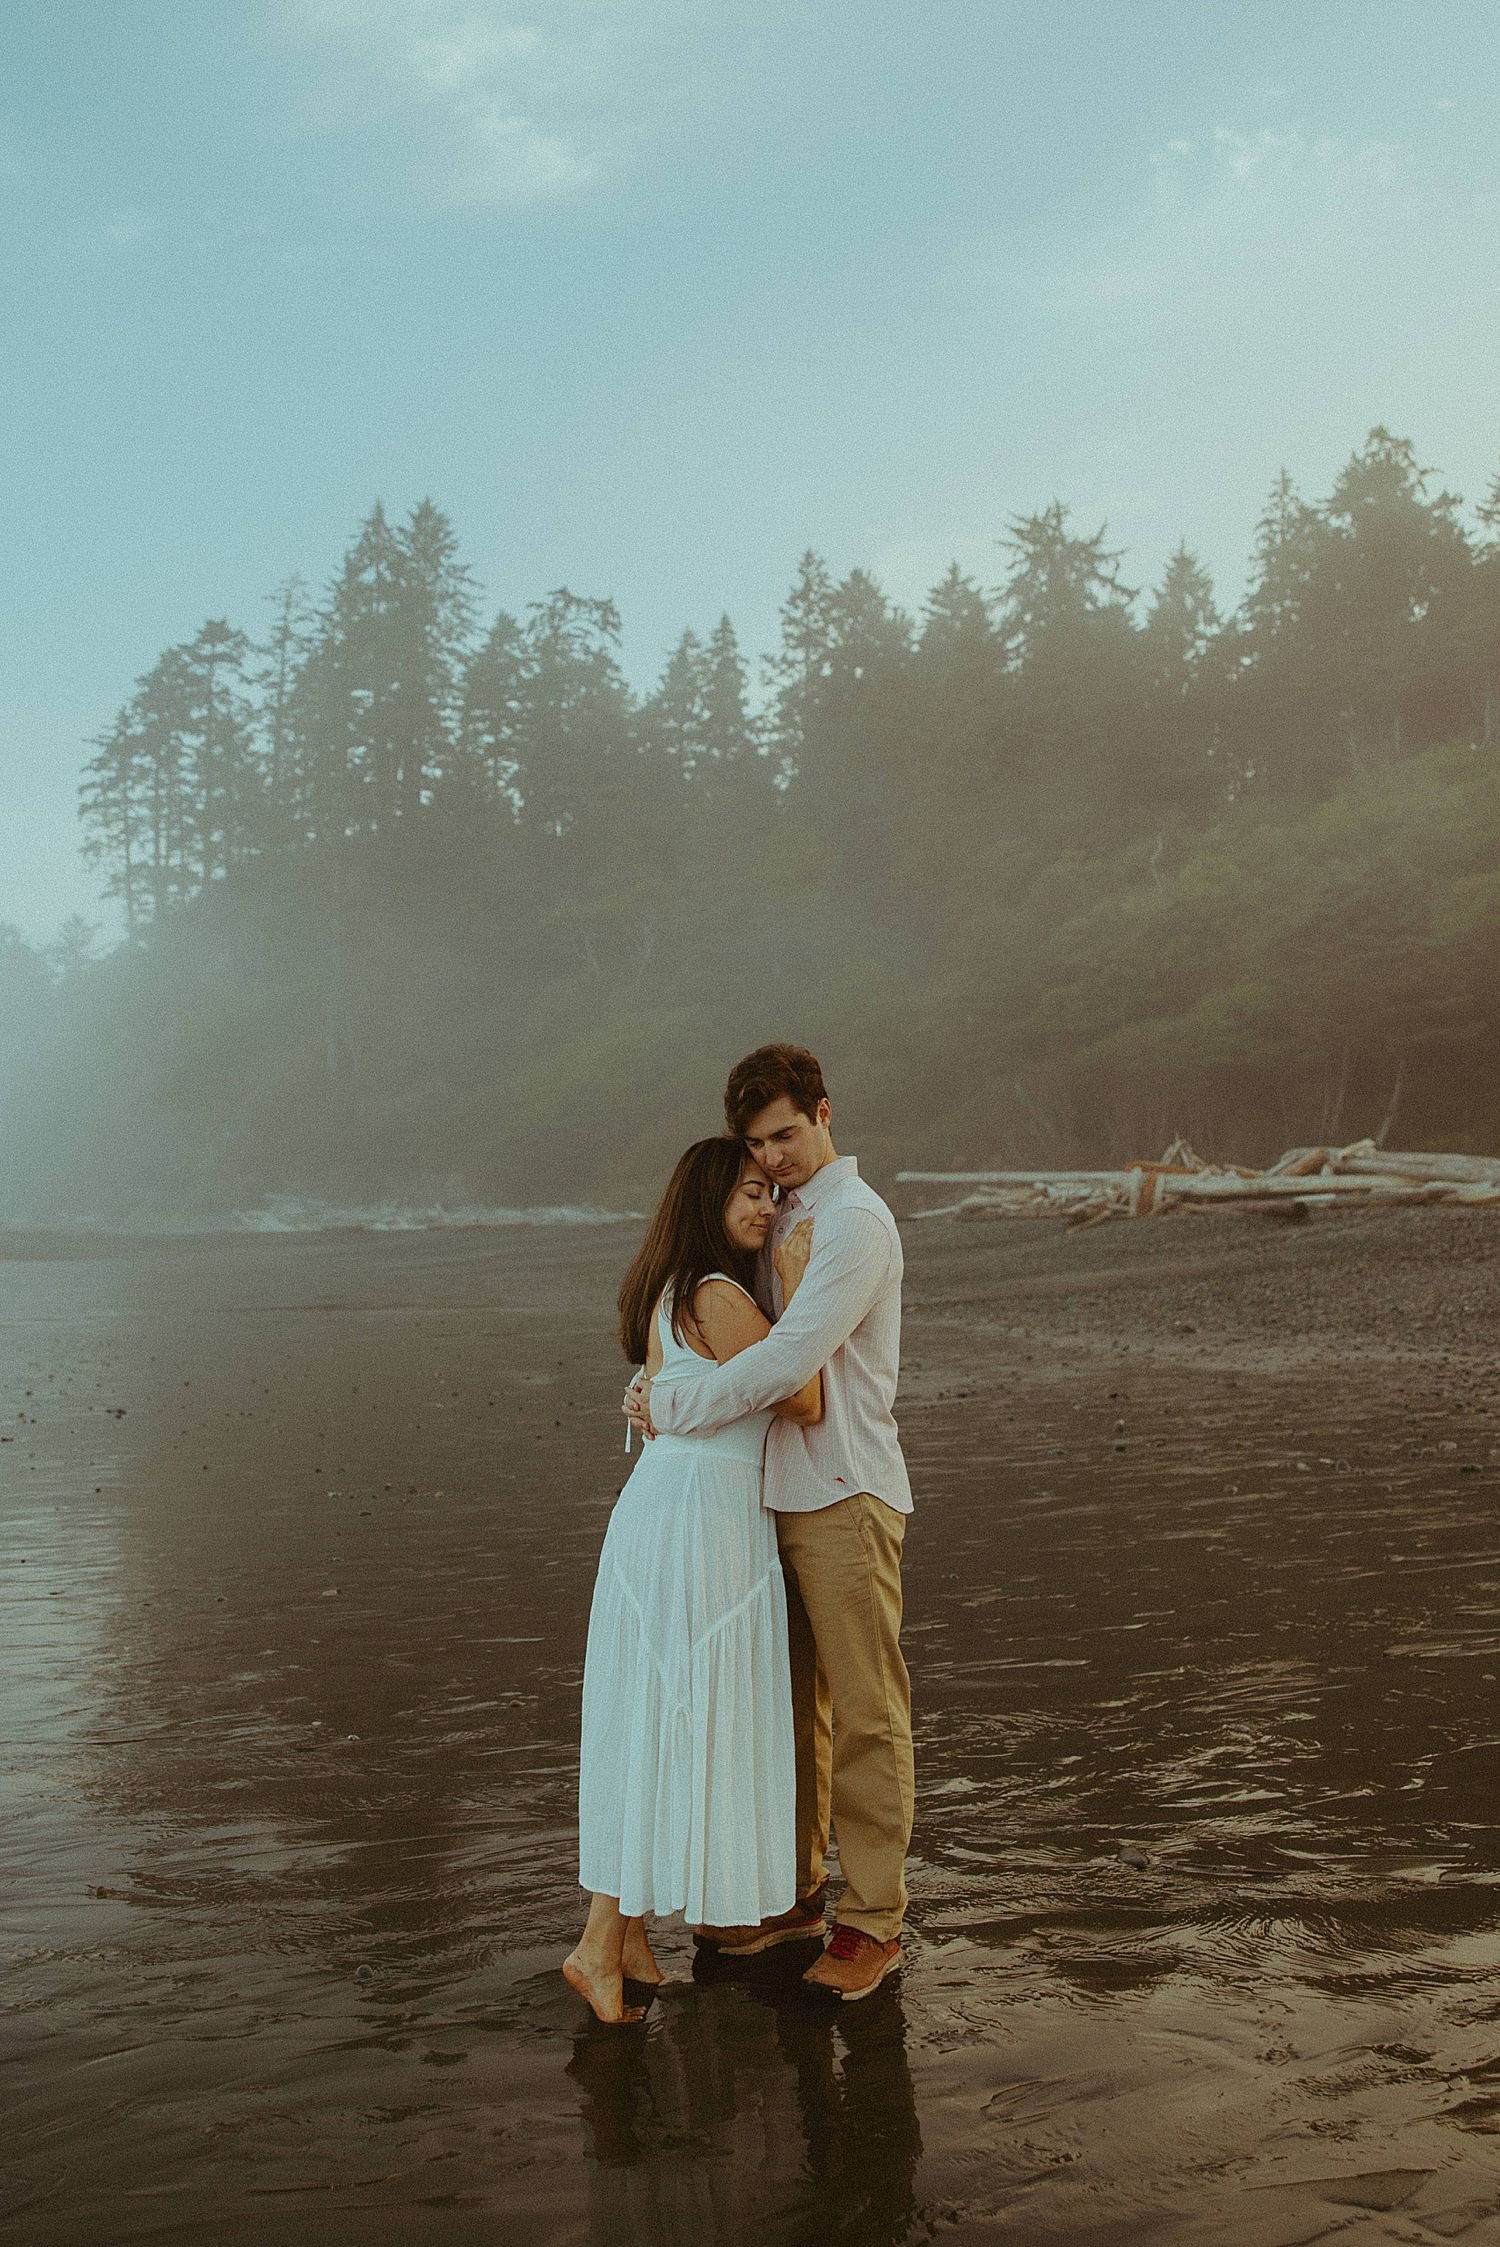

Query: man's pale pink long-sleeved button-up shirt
left=651, top=1155, right=912, bottom=1514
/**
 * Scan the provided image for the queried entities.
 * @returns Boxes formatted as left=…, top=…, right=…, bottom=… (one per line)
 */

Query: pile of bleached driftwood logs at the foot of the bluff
left=898, top=1139, right=1500, bottom=1229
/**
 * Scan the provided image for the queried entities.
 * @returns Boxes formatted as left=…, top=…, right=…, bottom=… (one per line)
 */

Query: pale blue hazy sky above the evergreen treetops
left=0, top=0, right=1500, bottom=941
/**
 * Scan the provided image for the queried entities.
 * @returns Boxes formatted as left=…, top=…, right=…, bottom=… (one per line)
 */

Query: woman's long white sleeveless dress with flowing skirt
left=577, top=1274, right=797, bottom=1926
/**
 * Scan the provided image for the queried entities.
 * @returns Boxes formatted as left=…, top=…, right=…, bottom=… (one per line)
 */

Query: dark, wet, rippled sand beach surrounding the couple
left=0, top=1209, right=1500, bottom=2247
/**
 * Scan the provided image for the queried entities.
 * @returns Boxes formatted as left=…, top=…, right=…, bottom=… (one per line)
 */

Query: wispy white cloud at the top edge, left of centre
left=283, top=0, right=767, bottom=204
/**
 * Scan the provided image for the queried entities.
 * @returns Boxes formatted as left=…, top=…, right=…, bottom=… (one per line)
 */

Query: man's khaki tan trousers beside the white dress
left=777, top=1492, right=914, bottom=1941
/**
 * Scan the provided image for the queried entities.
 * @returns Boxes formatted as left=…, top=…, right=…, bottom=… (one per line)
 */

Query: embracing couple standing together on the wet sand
left=564, top=1045, right=912, bottom=2022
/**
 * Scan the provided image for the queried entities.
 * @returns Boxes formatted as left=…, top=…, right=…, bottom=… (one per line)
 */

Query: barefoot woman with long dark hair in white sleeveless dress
left=564, top=1139, right=822, bottom=2022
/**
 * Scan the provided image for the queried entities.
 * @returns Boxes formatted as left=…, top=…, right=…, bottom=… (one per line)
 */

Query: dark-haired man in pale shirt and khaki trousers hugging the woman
left=626, top=1045, right=914, bottom=2000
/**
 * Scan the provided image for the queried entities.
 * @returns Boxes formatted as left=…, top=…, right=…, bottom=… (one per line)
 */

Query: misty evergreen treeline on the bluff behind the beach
left=0, top=429, right=1500, bottom=1213
